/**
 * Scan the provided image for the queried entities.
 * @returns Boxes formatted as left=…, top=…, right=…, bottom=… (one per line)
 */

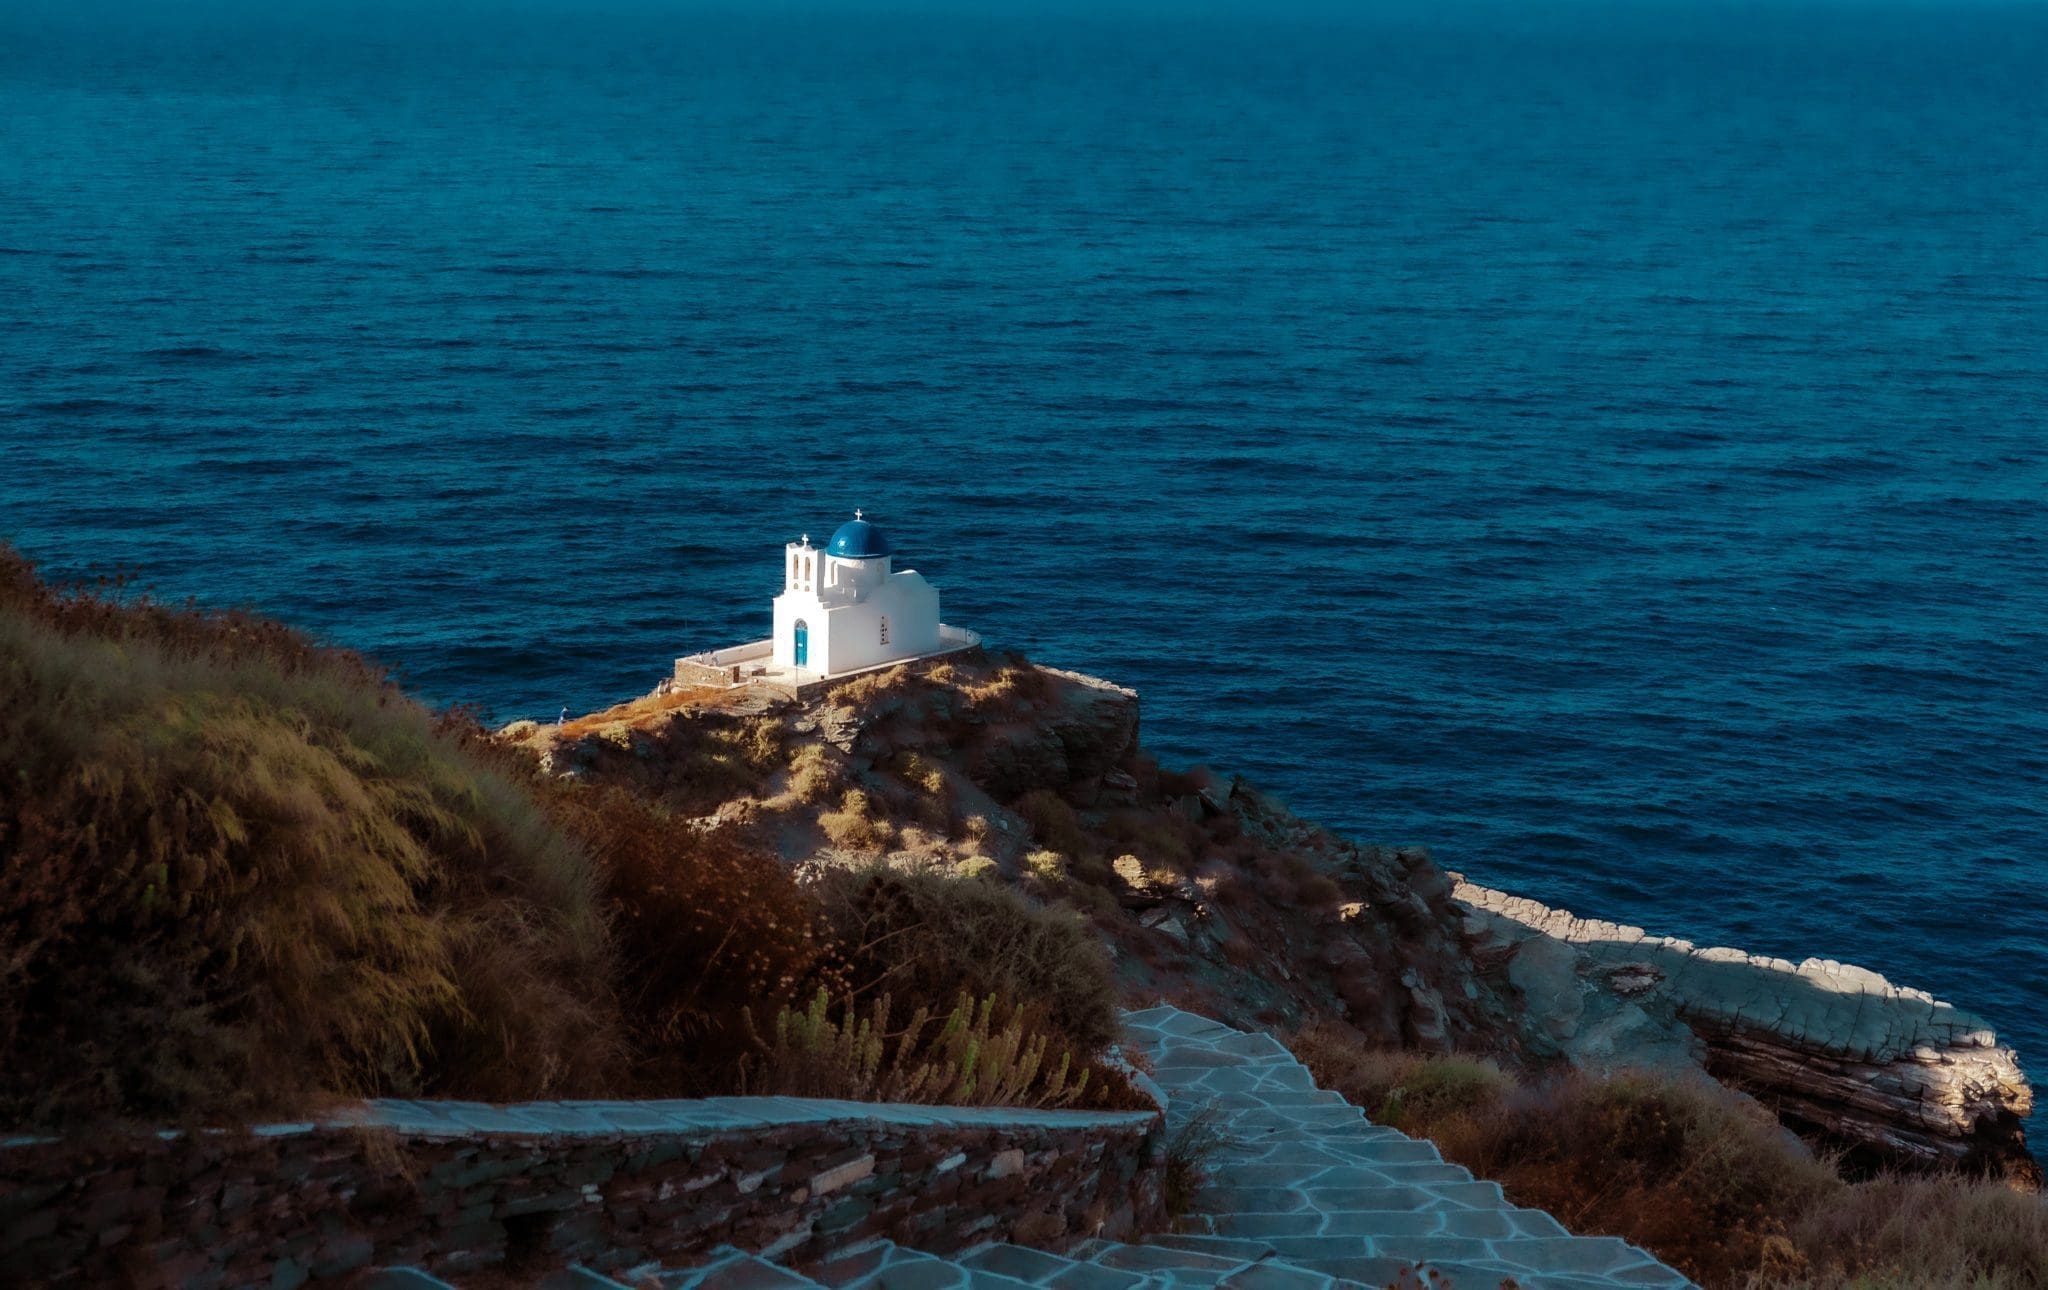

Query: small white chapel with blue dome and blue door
left=774, top=510, right=961, bottom=676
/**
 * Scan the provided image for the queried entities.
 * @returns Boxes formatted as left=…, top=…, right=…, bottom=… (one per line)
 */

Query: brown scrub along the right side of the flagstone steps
left=1292, top=1022, right=2048, bottom=1290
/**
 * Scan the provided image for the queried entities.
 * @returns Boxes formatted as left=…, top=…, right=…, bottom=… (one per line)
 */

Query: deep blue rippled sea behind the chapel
left=0, top=0, right=2048, bottom=1113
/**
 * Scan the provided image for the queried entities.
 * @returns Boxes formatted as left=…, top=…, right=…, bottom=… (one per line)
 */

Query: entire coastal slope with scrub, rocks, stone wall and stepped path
left=0, top=547, right=2048, bottom=1290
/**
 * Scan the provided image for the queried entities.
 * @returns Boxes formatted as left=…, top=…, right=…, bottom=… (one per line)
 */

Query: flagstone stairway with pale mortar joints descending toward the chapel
left=373, top=1007, right=1692, bottom=1290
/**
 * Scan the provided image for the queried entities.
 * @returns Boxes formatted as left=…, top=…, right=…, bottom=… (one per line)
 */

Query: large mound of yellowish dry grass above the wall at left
left=0, top=551, right=618, bottom=1124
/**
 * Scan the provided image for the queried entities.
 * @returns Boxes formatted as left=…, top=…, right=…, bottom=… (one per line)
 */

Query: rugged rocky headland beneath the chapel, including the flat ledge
left=502, top=653, right=2040, bottom=1184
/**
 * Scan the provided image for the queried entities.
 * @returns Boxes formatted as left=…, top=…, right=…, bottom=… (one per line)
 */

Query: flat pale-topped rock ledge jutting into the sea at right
left=1452, top=878, right=2038, bottom=1179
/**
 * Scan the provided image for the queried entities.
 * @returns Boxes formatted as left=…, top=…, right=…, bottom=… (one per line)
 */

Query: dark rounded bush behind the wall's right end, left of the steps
left=815, top=864, right=1116, bottom=1059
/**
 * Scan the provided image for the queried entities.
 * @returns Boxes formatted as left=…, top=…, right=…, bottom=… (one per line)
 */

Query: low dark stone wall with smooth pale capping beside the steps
left=0, top=1098, right=1163, bottom=1288
